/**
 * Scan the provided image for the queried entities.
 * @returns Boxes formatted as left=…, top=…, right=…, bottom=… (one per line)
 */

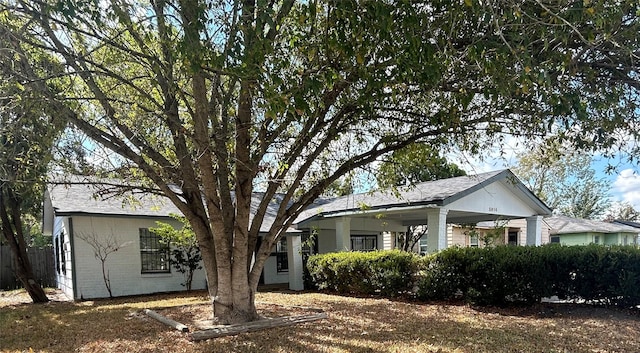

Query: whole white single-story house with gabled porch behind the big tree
left=43, top=170, right=551, bottom=299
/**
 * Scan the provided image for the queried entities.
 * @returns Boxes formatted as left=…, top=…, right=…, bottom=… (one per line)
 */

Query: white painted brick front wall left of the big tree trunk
left=73, top=213, right=206, bottom=299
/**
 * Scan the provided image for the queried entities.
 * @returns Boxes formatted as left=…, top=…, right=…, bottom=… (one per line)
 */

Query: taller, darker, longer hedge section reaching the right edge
left=417, top=245, right=640, bottom=306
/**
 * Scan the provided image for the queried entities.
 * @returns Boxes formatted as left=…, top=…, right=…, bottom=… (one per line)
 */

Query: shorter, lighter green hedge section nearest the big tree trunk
left=307, top=250, right=421, bottom=297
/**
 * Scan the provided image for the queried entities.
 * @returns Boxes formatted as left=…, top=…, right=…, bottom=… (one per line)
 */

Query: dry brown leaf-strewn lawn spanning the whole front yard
left=0, top=292, right=640, bottom=353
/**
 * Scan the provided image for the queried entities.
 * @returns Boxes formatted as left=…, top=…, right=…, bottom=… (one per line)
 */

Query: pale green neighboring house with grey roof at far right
left=545, top=215, right=640, bottom=245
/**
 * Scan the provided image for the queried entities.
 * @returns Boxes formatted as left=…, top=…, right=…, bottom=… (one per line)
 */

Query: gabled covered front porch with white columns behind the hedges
left=278, top=170, right=551, bottom=290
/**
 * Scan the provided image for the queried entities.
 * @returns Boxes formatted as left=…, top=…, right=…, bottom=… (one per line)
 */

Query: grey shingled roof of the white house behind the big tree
left=45, top=169, right=551, bottom=232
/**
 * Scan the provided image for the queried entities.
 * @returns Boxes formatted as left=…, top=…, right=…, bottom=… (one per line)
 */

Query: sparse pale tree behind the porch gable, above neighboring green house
left=512, top=141, right=611, bottom=219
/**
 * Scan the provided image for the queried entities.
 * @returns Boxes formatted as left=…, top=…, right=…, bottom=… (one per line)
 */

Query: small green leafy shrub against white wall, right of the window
left=150, top=215, right=202, bottom=291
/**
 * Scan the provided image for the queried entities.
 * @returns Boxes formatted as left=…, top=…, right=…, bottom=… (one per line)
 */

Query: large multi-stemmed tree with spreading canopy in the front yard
left=0, top=0, right=640, bottom=323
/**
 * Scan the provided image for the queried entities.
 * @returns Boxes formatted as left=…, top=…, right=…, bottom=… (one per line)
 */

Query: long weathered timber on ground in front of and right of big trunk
left=191, top=313, right=328, bottom=341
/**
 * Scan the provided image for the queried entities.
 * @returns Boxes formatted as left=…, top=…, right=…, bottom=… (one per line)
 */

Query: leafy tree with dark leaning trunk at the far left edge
left=0, top=19, right=65, bottom=303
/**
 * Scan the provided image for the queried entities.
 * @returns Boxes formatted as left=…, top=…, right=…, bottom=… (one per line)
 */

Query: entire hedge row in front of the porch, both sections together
left=307, top=245, right=640, bottom=306
